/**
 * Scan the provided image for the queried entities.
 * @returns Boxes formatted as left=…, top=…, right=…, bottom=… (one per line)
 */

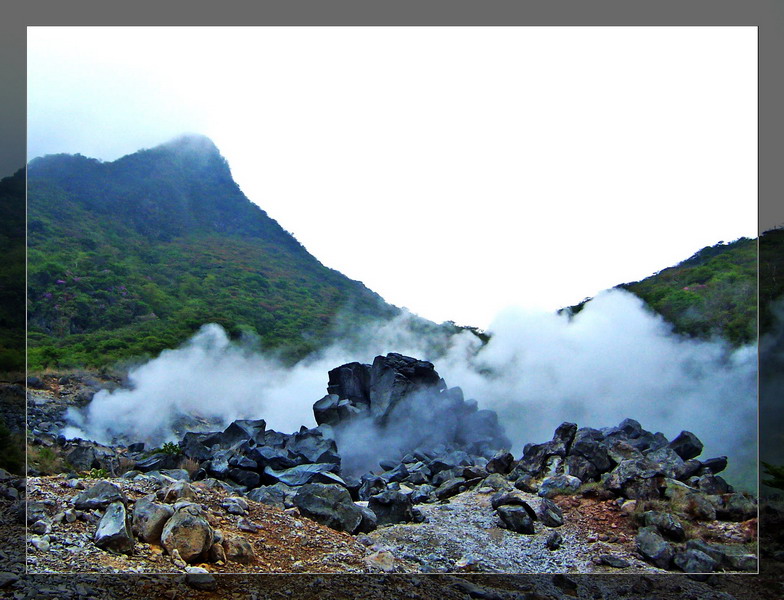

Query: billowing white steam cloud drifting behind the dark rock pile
left=64, top=290, right=757, bottom=488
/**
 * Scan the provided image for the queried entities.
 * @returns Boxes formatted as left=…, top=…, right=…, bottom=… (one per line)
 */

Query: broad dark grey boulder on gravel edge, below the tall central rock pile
left=294, top=483, right=366, bottom=533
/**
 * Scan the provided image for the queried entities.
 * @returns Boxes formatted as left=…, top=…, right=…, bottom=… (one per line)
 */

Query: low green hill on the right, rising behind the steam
left=568, top=232, right=760, bottom=345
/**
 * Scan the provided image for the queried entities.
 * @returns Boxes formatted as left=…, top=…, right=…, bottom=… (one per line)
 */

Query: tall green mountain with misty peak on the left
left=28, top=135, right=399, bottom=370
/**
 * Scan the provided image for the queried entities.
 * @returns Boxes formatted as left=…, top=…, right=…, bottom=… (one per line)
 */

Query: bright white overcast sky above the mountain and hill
left=28, top=27, right=757, bottom=327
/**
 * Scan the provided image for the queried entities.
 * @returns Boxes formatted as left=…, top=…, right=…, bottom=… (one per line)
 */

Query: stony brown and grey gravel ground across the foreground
left=0, top=354, right=784, bottom=600
